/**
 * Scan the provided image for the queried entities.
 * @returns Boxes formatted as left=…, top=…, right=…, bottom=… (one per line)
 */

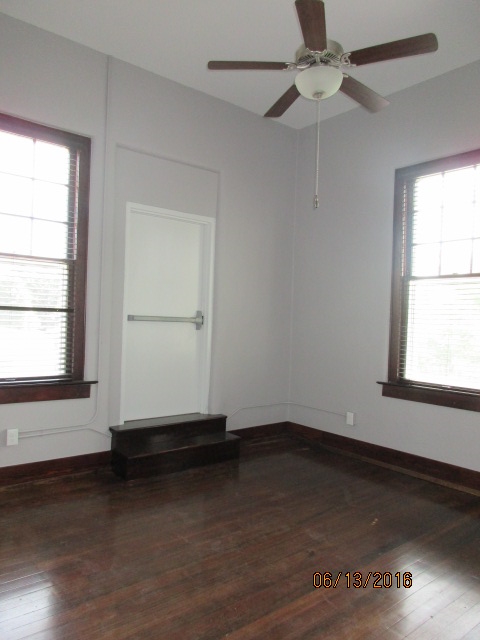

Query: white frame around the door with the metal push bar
left=120, top=202, right=216, bottom=423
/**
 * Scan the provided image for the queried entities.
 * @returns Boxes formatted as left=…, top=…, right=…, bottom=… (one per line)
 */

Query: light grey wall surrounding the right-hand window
left=290, top=62, right=480, bottom=470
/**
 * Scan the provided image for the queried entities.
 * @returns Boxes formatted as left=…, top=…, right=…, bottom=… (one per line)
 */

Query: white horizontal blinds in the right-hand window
left=399, top=164, right=480, bottom=390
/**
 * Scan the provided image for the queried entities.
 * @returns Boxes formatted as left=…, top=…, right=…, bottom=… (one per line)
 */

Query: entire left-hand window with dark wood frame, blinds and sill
left=0, top=114, right=91, bottom=403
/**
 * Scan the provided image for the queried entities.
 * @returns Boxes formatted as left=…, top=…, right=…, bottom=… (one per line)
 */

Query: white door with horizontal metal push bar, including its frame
left=122, top=203, right=215, bottom=420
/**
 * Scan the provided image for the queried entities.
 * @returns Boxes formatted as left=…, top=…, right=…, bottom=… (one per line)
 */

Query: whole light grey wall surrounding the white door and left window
left=0, top=14, right=296, bottom=466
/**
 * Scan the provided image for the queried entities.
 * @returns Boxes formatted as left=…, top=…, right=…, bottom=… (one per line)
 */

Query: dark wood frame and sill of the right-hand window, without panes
left=378, top=150, right=480, bottom=411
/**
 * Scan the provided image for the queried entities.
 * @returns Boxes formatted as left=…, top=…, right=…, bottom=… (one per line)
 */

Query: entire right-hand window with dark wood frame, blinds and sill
left=381, top=150, right=480, bottom=411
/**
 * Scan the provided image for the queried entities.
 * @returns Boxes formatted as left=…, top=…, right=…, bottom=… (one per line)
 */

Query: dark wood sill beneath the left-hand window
left=0, top=380, right=97, bottom=404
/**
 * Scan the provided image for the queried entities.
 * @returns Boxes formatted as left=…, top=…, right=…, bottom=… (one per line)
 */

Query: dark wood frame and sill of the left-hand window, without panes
left=0, top=114, right=96, bottom=404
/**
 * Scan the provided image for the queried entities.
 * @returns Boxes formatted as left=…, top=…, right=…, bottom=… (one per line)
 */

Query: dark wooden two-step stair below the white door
left=110, top=413, right=240, bottom=480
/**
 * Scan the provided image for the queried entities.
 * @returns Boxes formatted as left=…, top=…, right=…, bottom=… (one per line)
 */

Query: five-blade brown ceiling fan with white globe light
left=208, top=0, right=438, bottom=118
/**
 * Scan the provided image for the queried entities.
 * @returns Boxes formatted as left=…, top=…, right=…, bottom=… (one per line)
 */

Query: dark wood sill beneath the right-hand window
left=377, top=382, right=480, bottom=411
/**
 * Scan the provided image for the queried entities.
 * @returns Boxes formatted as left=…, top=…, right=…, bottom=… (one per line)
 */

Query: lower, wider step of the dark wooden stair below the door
left=112, top=432, right=240, bottom=480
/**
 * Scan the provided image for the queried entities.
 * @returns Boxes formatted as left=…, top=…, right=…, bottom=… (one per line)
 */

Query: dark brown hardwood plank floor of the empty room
left=0, top=437, right=480, bottom=640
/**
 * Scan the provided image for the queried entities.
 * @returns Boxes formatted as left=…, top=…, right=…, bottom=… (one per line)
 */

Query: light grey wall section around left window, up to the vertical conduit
left=0, top=14, right=109, bottom=466
